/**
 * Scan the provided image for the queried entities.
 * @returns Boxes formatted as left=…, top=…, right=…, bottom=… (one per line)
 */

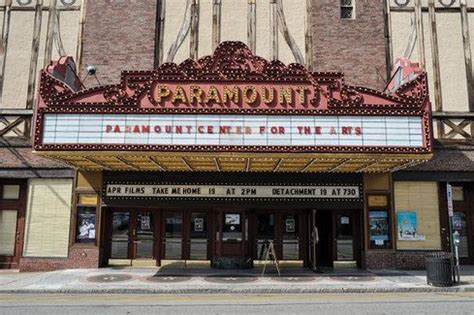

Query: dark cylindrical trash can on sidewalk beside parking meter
left=426, top=252, right=453, bottom=287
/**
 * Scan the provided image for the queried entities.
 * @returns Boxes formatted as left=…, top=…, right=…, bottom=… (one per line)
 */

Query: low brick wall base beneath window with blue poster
left=362, top=251, right=444, bottom=270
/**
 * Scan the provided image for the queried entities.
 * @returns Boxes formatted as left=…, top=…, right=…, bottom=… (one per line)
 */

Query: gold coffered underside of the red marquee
left=35, top=151, right=432, bottom=173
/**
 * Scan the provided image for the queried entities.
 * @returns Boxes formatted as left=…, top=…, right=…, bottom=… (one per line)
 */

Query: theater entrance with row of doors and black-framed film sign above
left=102, top=172, right=363, bottom=267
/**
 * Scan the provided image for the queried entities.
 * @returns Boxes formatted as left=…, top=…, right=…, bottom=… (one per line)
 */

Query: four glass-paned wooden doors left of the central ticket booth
left=108, top=209, right=210, bottom=264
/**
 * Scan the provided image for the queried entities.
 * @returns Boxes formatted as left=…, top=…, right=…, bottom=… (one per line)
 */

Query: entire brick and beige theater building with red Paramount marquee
left=8, top=0, right=474, bottom=271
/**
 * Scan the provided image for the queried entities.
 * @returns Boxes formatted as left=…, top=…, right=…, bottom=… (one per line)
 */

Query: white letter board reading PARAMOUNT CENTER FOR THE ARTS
left=43, top=114, right=423, bottom=150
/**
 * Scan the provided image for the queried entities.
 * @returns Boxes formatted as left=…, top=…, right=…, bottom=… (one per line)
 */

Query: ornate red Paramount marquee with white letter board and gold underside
left=34, top=42, right=432, bottom=171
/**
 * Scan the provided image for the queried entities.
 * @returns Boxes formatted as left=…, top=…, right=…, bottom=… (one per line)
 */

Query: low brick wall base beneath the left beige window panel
left=20, top=248, right=99, bottom=271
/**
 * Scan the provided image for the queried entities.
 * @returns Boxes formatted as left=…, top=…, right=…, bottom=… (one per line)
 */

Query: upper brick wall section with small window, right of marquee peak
left=312, top=0, right=386, bottom=89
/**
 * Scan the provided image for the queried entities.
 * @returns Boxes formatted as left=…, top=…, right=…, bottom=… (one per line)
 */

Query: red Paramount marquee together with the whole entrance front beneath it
left=34, top=42, right=432, bottom=269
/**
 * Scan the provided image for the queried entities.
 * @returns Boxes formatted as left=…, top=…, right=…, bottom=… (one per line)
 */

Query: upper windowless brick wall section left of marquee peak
left=80, top=0, right=157, bottom=87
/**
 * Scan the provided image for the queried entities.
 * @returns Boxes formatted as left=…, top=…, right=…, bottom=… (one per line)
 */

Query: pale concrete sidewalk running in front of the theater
left=0, top=266, right=474, bottom=294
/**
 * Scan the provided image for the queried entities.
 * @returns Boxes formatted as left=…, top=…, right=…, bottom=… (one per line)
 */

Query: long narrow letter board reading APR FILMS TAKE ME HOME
left=104, top=183, right=360, bottom=199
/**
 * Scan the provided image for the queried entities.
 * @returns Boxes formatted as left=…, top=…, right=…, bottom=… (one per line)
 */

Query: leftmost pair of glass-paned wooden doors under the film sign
left=109, top=210, right=155, bottom=259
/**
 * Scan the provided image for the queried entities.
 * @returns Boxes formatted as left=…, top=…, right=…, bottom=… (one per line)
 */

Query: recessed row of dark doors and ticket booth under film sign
left=107, top=208, right=361, bottom=269
